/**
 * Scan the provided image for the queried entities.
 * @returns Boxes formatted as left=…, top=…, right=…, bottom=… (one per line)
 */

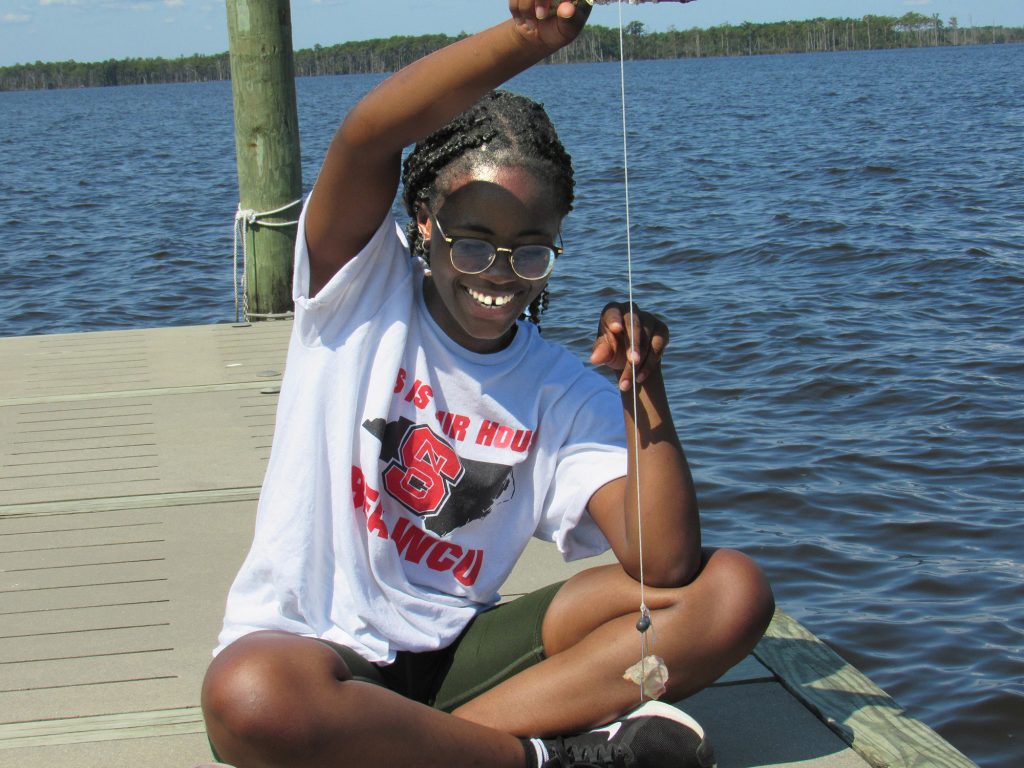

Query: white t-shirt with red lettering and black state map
left=215, top=201, right=626, bottom=663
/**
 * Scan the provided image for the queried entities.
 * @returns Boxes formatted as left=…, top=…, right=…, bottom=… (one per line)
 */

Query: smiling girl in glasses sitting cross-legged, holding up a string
left=203, top=0, right=773, bottom=768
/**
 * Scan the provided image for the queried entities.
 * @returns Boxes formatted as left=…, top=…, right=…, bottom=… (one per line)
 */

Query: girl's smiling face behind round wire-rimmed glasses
left=418, top=167, right=561, bottom=352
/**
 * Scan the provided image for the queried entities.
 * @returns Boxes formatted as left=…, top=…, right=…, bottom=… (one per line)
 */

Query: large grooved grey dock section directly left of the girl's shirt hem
left=0, top=500, right=255, bottom=721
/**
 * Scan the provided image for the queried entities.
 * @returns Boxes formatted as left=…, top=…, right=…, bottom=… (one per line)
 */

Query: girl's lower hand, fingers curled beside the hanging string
left=590, top=302, right=669, bottom=392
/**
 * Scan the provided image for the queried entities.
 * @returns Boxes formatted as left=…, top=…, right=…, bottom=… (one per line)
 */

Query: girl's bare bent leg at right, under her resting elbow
left=455, top=550, right=774, bottom=736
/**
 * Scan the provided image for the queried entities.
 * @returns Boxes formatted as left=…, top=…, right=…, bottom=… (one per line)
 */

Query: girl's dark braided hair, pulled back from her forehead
left=401, top=90, right=575, bottom=326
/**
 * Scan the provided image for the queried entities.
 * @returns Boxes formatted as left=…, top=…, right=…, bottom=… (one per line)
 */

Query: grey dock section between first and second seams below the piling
left=0, top=388, right=276, bottom=507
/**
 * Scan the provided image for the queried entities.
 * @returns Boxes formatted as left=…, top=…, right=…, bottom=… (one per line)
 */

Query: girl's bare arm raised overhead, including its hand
left=305, top=0, right=590, bottom=295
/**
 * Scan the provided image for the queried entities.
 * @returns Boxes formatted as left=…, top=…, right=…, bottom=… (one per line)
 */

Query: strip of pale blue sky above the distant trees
left=0, top=0, right=1024, bottom=67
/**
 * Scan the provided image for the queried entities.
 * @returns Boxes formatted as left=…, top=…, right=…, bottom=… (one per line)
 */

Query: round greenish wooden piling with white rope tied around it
left=227, top=0, right=302, bottom=319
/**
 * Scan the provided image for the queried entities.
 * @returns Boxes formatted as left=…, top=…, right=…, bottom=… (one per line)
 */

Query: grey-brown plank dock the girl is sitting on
left=0, top=322, right=974, bottom=768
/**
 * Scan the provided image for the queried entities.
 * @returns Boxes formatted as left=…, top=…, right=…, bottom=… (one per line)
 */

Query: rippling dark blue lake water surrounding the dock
left=0, top=46, right=1024, bottom=767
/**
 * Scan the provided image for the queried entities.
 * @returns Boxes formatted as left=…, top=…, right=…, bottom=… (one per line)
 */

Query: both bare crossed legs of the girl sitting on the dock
left=203, top=550, right=773, bottom=768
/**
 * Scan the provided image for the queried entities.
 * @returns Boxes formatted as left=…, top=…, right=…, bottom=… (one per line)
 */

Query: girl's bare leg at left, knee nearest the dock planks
left=203, top=632, right=525, bottom=768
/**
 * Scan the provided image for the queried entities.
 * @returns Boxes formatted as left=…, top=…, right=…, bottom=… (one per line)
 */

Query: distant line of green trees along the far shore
left=0, top=12, right=1024, bottom=91
